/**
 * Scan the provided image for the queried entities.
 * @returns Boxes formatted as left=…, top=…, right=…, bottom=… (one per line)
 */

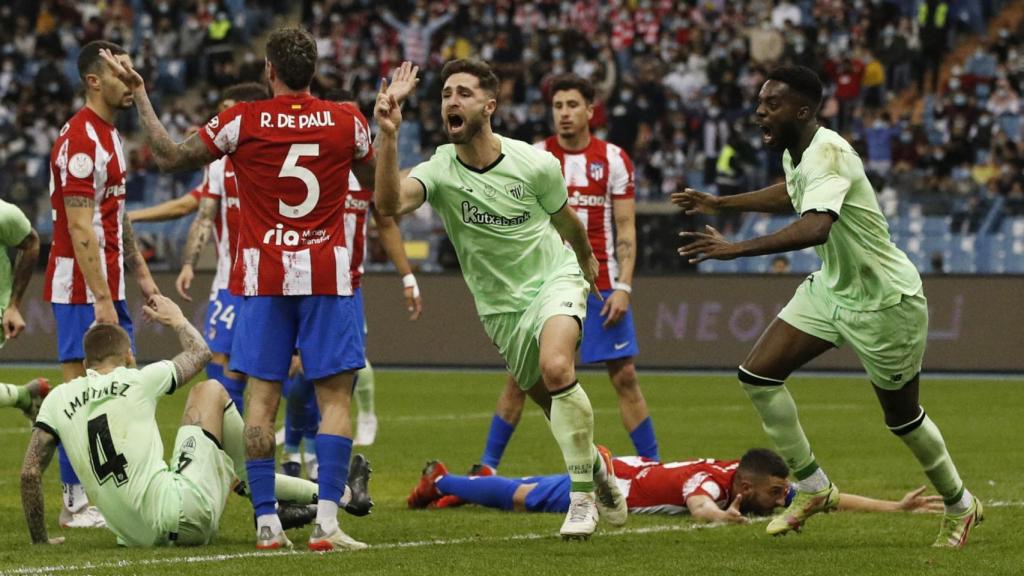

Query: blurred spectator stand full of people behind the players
left=0, top=0, right=1024, bottom=274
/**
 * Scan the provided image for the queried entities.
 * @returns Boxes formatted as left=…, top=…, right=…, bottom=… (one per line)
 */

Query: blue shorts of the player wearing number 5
left=230, top=295, right=366, bottom=382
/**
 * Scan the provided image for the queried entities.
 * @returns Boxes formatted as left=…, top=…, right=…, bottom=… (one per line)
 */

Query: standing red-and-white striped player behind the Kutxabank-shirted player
left=468, top=75, right=660, bottom=479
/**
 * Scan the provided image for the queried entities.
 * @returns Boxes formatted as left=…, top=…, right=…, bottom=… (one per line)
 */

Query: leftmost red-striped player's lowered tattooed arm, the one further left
left=63, top=196, right=118, bottom=324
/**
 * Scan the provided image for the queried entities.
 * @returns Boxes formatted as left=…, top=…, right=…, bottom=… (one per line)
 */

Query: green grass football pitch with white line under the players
left=0, top=365, right=1024, bottom=576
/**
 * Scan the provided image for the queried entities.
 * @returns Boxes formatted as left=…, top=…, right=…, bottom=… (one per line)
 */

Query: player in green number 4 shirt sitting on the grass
left=22, top=295, right=371, bottom=546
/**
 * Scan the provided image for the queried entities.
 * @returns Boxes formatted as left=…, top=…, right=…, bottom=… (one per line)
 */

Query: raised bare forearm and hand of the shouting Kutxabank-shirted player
left=374, top=80, right=427, bottom=216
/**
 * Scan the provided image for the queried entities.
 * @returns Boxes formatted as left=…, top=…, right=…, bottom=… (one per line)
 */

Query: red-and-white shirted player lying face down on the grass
left=408, top=446, right=942, bottom=524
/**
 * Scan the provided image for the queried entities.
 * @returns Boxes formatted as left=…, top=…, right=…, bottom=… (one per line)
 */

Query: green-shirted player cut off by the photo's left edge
left=0, top=200, right=50, bottom=420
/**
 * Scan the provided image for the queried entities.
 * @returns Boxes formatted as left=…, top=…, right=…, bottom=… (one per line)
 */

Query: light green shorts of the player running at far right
left=778, top=276, right=928, bottom=390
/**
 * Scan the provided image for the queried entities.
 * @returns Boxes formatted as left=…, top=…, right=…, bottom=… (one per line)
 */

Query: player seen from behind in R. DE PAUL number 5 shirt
left=100, top=28, right=374, bottom=550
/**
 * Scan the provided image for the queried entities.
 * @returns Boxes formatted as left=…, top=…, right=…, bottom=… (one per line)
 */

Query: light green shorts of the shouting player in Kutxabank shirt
left=480, top=275, right=590, bottom=390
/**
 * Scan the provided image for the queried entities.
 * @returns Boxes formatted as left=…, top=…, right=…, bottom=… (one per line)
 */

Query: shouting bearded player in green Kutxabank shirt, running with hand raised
left=374, top=59, right=626, bottom=539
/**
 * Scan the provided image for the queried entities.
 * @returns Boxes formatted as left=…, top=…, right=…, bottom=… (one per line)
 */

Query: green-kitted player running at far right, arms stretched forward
left=672, top=67, right=982, bottom=548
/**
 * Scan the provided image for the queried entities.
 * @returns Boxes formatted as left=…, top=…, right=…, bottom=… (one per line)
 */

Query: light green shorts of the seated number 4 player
left=171, top=425, right=234, bottom=546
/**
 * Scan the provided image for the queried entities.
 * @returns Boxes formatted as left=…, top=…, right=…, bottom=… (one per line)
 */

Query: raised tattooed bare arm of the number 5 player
left=99, top=49, right=215, bottom=172
